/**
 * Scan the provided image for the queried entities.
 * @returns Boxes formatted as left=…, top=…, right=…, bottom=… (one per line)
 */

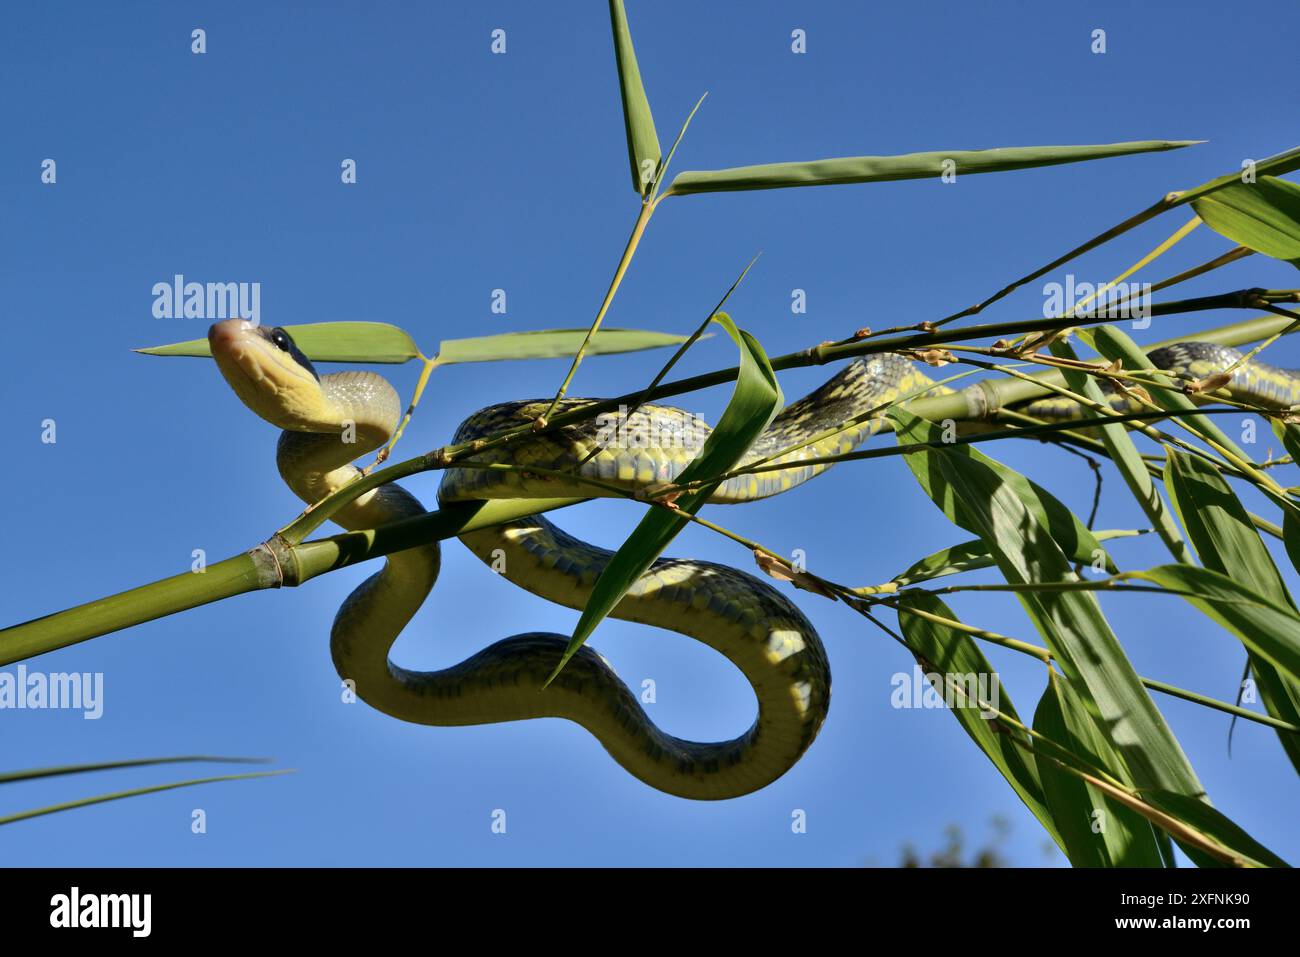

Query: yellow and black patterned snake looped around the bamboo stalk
left=208, top=319, right=1300, bottom=801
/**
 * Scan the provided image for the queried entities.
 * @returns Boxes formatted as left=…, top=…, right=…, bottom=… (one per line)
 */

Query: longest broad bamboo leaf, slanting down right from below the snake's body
left=888, top=407, right=1203, bottom=797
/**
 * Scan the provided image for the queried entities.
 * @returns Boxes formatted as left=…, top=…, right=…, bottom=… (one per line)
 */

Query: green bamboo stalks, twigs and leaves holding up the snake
left=10, top=0, right=1300, bottom=867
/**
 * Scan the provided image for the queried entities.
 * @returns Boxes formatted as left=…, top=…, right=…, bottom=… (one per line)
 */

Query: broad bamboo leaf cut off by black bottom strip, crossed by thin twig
left=1034, top=672, right=1170, bottom=867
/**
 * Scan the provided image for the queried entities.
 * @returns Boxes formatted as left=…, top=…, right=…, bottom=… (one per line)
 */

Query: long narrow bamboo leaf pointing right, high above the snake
left=668, top=139, right=1197, bottom=195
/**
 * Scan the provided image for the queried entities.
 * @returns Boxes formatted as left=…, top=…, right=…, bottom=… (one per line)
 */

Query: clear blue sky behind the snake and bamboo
left=0, top=0, right=1300, bottom=865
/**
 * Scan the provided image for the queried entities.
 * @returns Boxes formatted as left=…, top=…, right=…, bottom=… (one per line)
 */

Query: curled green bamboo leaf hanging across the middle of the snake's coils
left=547, top=312, right=781, bottom=681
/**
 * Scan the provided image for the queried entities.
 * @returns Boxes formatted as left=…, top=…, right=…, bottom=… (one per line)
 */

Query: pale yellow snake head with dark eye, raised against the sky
left=208, top=319, right=327, bottom=432
